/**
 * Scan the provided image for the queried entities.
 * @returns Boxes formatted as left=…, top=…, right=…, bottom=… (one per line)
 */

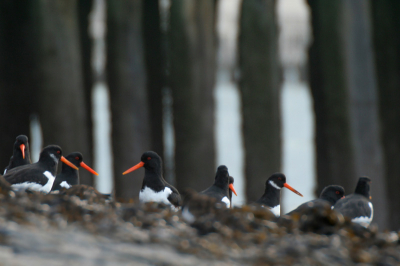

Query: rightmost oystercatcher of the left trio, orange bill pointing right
left=51, top=152, right=99, bottom=191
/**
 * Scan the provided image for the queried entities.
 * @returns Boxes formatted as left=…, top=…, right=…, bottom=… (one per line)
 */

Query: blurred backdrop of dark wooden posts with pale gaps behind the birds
left=0, top=0, right=400, bottom=229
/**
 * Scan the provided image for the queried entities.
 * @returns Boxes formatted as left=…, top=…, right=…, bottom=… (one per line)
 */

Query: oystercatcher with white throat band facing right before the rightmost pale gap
left=256, top=173, right=303, bottom=217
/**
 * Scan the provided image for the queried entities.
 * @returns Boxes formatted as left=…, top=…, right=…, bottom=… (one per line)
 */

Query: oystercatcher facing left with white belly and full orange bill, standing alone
left=122, top=151, right=182, bottom=207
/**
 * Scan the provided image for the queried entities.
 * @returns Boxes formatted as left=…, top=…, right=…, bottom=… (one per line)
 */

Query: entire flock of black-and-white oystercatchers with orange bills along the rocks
left=2, top=135, right=373, bottom=227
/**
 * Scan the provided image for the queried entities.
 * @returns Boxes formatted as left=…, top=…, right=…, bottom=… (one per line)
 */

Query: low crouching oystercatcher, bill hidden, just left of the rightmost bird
left=286, top=185, right=344, bottom=215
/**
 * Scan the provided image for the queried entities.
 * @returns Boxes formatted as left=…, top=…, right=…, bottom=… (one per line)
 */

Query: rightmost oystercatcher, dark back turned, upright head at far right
left=334, top=177, right=374, bottom=227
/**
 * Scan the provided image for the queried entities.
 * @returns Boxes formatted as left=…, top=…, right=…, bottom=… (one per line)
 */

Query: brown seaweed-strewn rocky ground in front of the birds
left=0, top=190, right=400, bottom=265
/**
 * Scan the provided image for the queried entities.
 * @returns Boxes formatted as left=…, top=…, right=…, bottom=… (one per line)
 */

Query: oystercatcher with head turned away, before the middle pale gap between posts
left=200, top=165, right=237, bottom=208
